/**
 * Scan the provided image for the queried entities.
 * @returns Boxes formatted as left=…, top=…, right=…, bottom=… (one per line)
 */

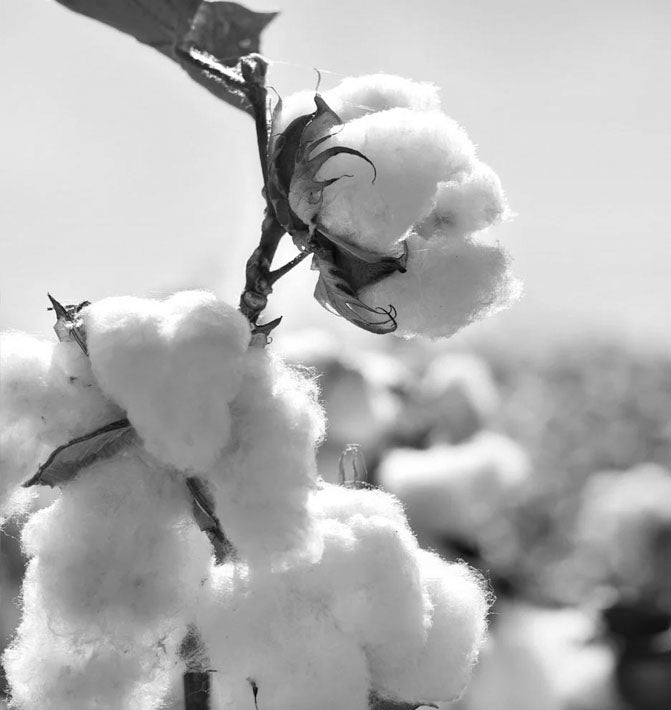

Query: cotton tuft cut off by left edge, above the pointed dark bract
left=0, top=333, right=121, bottom=521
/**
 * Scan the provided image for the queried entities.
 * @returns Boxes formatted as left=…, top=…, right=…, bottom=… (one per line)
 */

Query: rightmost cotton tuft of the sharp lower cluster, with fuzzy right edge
left=388, top=550, right=490, bottom=702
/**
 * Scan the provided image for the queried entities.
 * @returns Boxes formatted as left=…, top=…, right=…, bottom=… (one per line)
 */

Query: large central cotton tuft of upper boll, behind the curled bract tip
left=302, top=108, right=475, bottom=252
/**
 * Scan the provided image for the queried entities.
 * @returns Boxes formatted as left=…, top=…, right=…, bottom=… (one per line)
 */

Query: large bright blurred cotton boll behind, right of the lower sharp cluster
left=379, top=432, right=530, bottom=543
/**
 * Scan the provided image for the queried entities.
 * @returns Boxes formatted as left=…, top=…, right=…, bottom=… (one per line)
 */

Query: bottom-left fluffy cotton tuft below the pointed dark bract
left=3, top=451, right=210, bottom=710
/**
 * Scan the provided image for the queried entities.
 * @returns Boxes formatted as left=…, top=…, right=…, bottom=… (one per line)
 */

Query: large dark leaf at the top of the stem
left=51, top=0, right=276, bottom=108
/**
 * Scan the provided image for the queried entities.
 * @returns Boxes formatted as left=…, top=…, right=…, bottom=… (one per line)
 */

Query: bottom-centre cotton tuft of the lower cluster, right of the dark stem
left=199, top=565, right=369, bottom=710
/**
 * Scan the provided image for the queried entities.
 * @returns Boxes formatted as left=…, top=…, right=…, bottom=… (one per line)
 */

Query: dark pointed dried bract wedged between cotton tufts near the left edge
left=23, top=419, right=137, bottom=488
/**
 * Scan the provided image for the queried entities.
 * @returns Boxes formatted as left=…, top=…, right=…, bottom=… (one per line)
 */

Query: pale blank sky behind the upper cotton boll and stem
left=0, top=0, right=671, bottom=344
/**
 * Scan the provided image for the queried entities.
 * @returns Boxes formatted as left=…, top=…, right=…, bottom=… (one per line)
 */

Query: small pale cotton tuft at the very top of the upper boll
left=324, top=74, right=440, bottom=121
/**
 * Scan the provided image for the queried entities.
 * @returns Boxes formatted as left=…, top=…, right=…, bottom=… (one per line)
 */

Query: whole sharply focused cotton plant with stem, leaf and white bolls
left=0, top=2, right=519, bottom=710
